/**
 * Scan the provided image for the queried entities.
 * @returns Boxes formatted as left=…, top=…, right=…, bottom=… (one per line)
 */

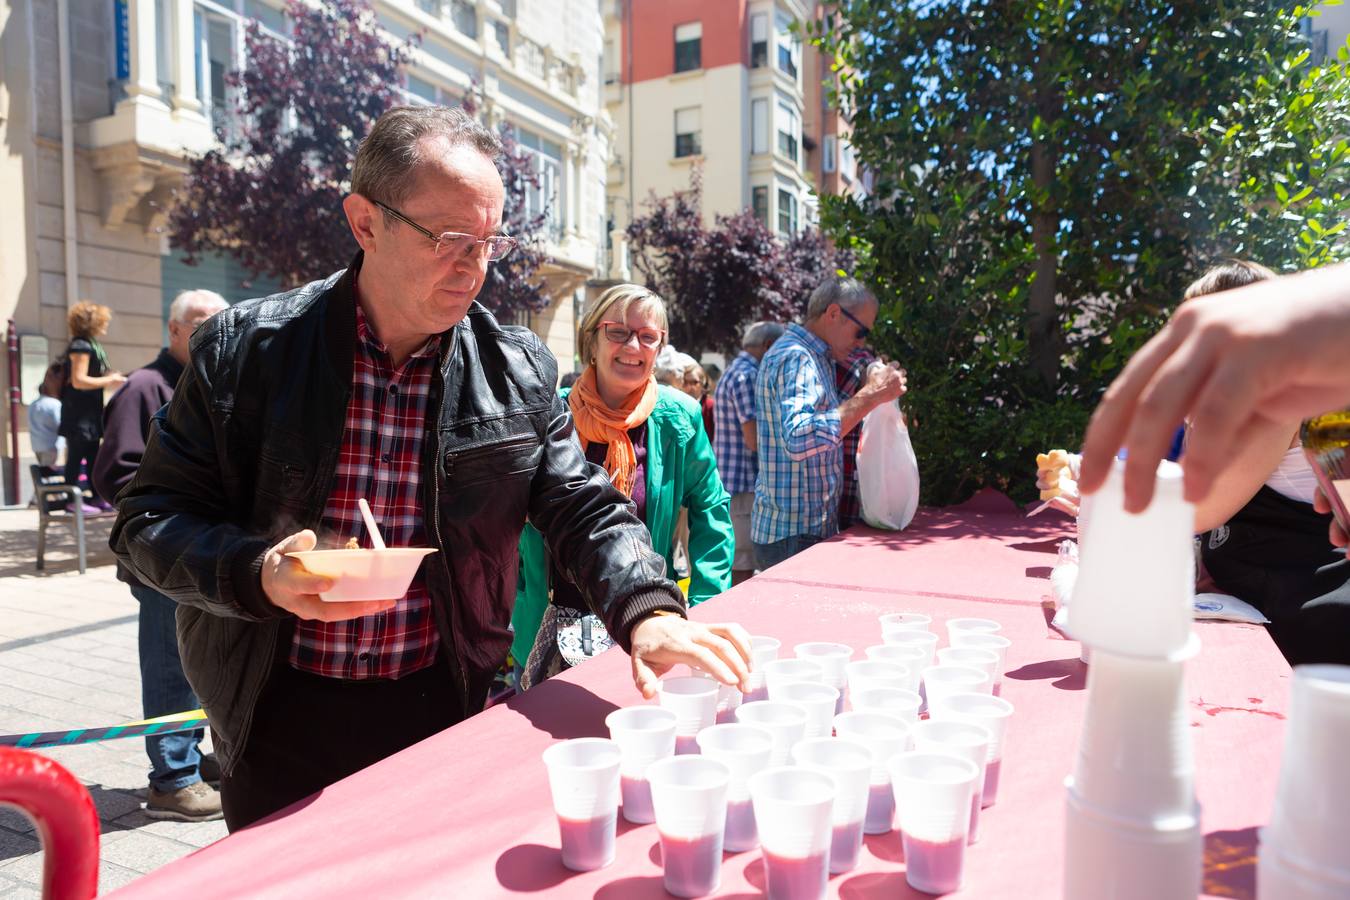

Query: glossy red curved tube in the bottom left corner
left=0, top=748, right=99, bottom=900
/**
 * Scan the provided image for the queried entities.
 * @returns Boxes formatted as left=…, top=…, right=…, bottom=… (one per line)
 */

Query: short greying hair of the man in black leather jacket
left=351, top=107, right=502, bottom=206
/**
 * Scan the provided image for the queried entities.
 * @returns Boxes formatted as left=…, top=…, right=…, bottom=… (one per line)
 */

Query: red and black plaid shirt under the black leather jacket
left=290, top=302, right=440, bottom=680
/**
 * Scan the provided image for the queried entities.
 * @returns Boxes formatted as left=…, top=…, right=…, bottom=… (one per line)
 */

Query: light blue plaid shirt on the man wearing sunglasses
left=751, top=324, right=842, bottom=544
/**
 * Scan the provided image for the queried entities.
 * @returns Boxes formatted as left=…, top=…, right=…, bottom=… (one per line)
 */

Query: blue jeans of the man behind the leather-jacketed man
left=131, top=584, right=205, bottom=792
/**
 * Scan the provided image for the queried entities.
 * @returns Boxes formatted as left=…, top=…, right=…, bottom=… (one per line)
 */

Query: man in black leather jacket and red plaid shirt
left=112, top=108, right=749, bottom=828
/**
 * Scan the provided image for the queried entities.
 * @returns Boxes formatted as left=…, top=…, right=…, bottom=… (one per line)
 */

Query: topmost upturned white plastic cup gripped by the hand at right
left=1064, top=460, right=1195, bottom=664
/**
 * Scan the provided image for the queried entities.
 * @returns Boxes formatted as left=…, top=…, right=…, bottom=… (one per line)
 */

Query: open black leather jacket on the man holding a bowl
left=111, top=255, right=684, bottom=772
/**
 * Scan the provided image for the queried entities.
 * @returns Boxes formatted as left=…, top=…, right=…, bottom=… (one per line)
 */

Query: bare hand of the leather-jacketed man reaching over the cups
left=630, top=615, right=751, bottom=700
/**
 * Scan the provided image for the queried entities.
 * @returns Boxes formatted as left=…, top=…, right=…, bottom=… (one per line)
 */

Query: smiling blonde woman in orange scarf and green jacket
left=512, top=285, right=734, bottom=688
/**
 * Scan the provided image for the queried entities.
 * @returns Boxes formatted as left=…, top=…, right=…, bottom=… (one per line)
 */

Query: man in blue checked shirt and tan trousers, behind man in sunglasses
left=713, top=322, right=783, bottom=584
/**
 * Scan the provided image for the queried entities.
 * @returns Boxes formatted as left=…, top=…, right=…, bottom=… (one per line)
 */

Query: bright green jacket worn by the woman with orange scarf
left=510, top=385, right=736, bottom=665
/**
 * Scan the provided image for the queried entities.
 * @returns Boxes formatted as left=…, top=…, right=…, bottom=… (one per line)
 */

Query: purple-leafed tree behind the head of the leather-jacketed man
left=167, top=0, right=547, bottom=322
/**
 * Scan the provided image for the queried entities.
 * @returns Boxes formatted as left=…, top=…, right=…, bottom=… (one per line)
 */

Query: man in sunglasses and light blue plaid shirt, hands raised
left=751, top=275, right=906, bottom=569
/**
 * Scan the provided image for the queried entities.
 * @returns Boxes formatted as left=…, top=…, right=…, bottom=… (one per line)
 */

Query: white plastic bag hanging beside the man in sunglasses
left=857, top=401, right=919, bottom=532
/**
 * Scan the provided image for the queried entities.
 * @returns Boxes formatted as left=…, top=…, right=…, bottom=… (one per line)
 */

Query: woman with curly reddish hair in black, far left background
left=59, top=301, right=127, bottom=509
